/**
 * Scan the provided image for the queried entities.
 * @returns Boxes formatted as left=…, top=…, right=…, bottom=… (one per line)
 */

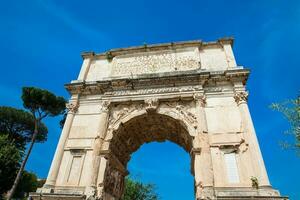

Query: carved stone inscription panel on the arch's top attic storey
left=112, top=48, right=200, bottom=76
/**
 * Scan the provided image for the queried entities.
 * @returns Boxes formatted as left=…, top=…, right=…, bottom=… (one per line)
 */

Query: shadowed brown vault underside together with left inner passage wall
left=104, top=113, right=193, bottom=200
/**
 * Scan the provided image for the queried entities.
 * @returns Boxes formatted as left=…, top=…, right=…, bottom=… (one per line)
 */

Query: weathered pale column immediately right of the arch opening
left=192, top=94, right=214, bottom=200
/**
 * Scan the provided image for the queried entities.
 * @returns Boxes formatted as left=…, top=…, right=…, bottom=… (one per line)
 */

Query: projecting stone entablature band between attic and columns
left=65, top=67, right=250, bottom=97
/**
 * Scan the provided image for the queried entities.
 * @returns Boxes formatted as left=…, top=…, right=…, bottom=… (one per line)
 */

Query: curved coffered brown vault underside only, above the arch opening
left=110, top=114, right=192, bottom=167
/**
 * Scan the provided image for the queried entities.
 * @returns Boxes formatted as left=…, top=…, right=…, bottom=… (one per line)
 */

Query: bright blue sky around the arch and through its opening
left=0, top=0, right=300, bottom=200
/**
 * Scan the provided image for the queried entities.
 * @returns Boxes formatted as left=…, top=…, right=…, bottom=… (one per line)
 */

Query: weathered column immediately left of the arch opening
left=85, top=101, right=110, bottom=196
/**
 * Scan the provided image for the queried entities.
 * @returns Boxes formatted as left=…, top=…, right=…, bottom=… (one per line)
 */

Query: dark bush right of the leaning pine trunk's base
left=14, top=171, right=39, bottom=199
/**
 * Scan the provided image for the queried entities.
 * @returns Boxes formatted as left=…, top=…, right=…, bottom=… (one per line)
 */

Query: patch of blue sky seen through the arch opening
left=124, top=141, right=195, bottom=200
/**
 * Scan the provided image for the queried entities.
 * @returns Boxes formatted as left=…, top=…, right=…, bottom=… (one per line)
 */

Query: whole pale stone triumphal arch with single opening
left=31, top=38, right=284, bottom=200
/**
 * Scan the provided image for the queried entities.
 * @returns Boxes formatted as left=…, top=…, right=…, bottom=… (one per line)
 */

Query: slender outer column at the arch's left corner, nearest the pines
left=44, top=97, right=79, bottom=188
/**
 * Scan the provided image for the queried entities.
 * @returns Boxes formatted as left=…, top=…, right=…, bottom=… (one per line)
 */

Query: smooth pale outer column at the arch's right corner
left=234, top=91, right=270, bottom=186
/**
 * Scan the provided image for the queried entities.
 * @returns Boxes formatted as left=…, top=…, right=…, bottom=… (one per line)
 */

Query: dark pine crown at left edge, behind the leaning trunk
left=0, top=106, right=48, bottom=150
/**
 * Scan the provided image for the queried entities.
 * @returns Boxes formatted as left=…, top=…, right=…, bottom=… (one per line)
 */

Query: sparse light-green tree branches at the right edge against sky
left=271, top=96, right=300, bottom=153
